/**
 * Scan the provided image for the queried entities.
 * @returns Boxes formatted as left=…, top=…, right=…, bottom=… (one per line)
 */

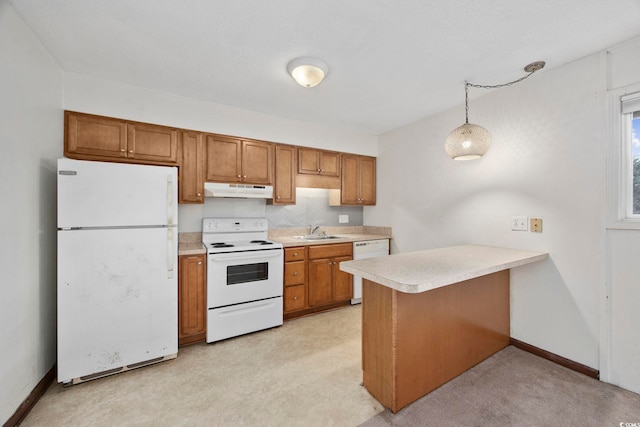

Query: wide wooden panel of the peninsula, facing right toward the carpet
left=390, top=270, right=510, bottom=412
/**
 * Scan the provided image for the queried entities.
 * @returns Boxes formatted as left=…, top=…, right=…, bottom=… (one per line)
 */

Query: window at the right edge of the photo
left=620, top=92, right=640, bottom=219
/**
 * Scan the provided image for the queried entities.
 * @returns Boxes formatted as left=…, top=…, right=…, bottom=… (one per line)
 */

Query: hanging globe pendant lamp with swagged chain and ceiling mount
left=444, top=61, right=545, bottom=160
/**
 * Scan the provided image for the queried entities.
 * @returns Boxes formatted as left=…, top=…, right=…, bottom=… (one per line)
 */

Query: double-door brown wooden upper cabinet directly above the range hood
left=206, top=134, right=273, bottom=185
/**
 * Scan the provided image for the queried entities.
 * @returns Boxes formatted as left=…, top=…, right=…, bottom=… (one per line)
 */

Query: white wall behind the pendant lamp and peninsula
left=364, top=54, right=606, bottom=369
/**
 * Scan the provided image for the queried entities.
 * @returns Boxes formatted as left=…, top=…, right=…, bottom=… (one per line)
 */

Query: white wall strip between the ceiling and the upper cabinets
left=64, top=73, right=378, bottom=156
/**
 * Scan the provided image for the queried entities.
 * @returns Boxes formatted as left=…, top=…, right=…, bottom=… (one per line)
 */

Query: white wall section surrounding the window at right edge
left=600, top=38, right=640, bottom=393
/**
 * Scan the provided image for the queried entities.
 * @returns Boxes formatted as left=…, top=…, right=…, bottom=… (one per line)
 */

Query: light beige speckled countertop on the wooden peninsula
left=340, top=245, right=549, bottom=293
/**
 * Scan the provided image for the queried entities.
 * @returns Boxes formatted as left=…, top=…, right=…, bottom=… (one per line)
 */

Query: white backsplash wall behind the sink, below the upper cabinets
left=265, top=188, right=363, bottom=228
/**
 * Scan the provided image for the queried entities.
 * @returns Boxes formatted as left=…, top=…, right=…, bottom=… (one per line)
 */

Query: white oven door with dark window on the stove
left=207, top=249, right=284, bottom=308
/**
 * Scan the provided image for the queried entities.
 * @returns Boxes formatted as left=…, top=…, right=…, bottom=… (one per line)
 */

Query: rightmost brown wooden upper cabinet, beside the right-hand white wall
left=340, top=154, right=376, bottom=205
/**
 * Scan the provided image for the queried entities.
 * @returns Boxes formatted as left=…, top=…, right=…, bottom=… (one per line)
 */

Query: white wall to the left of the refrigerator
left=0, top=1, right=63, bottom=424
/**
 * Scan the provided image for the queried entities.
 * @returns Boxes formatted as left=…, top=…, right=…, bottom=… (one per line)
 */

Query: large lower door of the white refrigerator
left=58, top=228, right=178, bottom=383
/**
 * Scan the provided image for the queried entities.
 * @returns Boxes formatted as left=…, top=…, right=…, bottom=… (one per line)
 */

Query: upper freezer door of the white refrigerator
left=58, top=158, right=178, bottom=228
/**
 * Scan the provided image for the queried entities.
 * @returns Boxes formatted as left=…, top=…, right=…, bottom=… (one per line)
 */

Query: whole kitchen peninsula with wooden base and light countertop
left=340, top=245, right=548, bottom=412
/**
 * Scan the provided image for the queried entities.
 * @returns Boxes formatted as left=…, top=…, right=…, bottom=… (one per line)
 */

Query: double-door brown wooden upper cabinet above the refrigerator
left=64, top=111, right=178, bottom=165
